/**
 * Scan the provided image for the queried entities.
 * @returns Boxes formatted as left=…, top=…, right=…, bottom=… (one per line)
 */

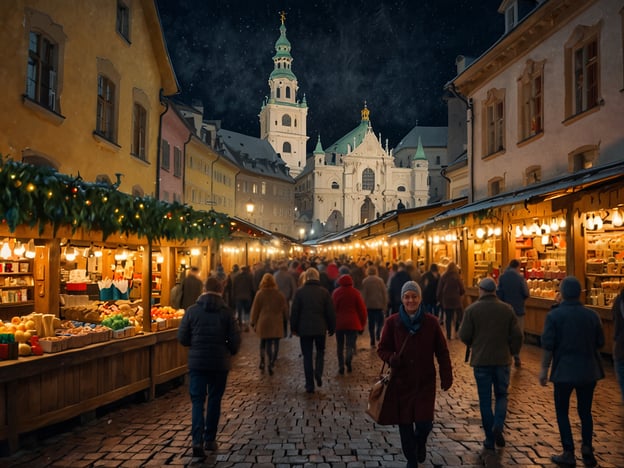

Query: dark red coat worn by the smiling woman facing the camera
left=377, top=314, right=453, bottom=424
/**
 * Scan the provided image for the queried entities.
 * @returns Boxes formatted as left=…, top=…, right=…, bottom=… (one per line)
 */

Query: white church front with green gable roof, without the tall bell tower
left=295, top=107, right=429, bottom=237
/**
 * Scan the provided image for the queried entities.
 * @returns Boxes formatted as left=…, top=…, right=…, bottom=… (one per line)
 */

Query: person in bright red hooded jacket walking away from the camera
left=332, top=275, right=367, bottom=374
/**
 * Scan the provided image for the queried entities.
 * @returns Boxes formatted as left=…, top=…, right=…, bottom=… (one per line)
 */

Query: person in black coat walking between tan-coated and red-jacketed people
left=290, top=268, right=336, bottom=393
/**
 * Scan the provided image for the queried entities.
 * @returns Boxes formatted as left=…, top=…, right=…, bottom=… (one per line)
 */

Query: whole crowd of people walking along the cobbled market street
left=173, top=258, right=624, bottom=467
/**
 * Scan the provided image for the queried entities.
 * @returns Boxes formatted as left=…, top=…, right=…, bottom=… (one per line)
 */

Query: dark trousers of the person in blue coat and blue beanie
left=555, top=382, right=596, bottom=452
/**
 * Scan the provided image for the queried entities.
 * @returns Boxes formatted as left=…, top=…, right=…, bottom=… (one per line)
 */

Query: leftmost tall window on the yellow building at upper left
left=26, top=31, right=57, bottom=111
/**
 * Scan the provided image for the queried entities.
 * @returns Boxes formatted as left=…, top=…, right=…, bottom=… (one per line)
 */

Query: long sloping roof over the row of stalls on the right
left=432, top=161, right=624, bottom=224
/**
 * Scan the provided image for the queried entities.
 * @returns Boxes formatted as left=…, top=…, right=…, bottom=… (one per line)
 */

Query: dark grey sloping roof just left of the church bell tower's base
left=217, top=129, right=294, bottom=182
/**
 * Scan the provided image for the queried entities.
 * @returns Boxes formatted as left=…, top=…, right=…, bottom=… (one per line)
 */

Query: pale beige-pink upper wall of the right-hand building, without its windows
left=460, top=0, right=624, bottom=199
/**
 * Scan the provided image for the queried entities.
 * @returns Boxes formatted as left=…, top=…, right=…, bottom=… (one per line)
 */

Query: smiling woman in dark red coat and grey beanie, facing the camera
left=377, top=281, right=453, bottom=467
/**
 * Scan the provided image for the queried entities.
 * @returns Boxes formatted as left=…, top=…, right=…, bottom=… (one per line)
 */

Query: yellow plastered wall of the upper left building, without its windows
left=0, top=0, right=177, bottom=195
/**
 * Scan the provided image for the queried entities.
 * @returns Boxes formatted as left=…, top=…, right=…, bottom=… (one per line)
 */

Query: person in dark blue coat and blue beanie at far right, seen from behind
left=540, top=276, right=604, bottom=466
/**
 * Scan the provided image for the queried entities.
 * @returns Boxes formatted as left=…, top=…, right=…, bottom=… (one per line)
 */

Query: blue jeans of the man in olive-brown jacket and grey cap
left=474, top=366, right=510, bottom=448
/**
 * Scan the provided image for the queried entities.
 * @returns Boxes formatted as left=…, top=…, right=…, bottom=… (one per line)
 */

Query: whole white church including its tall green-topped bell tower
left=259, top=16, right=429, bottom=237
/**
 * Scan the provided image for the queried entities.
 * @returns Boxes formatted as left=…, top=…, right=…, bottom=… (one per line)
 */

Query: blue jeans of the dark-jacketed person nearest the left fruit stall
left=189, top=370, right=228, bottom=446
